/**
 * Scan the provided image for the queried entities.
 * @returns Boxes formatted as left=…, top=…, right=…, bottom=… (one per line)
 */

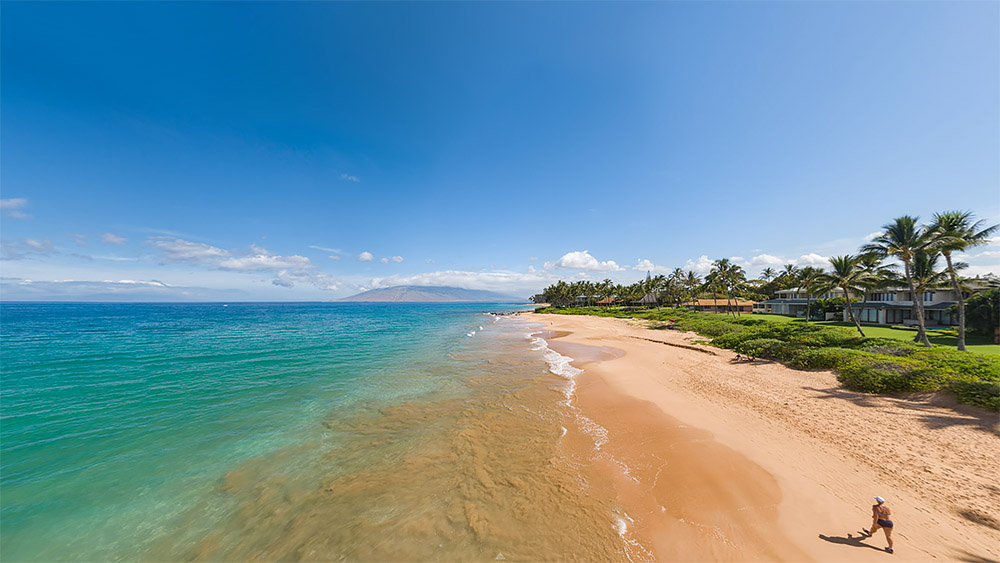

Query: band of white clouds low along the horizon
left=0, top=228, right=1000, bottom=301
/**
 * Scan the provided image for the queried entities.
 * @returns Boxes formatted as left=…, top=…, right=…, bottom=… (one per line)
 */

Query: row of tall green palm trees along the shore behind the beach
left=536, top=211, right=1000, bottom=351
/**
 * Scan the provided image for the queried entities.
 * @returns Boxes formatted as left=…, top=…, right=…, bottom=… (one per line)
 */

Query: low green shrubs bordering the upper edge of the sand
left=537, top=307, right=1000, bottom=411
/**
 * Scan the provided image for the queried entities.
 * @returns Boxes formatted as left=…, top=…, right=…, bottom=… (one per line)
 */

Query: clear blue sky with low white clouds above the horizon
left=0, top=1, right=1000, bottom=301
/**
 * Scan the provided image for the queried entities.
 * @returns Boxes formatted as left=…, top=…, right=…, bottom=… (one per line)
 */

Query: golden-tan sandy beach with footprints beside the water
left=525, top=314, right=1000, bottom=561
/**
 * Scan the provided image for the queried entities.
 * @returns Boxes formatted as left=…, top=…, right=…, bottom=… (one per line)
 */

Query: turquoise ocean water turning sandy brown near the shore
left=0, top=303, right=639, bottom=561
